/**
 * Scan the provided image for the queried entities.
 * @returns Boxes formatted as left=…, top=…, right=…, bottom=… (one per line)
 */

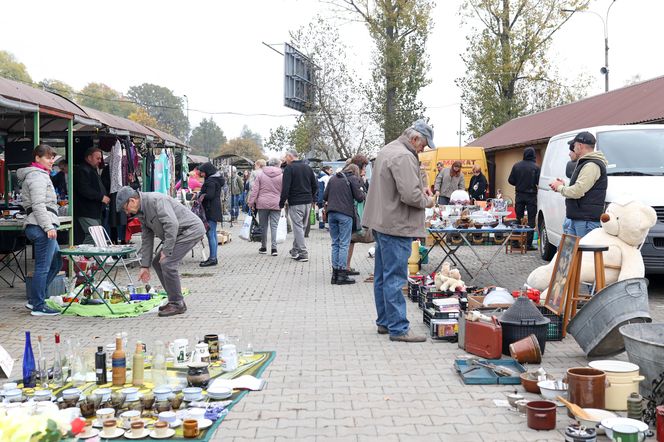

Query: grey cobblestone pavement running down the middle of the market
left=0, top=218, right=664, bottom=441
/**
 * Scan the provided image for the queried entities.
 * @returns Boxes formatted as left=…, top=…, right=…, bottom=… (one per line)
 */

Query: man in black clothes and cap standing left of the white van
left=507, top=147, right=540, bottom=250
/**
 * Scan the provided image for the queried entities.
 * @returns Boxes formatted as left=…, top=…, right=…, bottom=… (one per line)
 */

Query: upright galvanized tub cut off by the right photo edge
left=620, top=324, right=664, bottom=396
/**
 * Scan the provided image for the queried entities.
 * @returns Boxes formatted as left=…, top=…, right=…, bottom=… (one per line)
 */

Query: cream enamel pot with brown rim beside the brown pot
left=588, top=360, right=645, bottom=411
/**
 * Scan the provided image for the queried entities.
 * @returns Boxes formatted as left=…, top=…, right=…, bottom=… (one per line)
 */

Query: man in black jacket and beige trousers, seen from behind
left=279, top=150, right=318, bottom=262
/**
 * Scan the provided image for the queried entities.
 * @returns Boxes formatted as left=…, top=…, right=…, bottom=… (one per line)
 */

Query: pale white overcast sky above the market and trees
left=0, top=0, right=664, bottom=146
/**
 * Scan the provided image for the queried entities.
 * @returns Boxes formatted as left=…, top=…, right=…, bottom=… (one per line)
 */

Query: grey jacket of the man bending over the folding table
left=136, top=192, right=205, bottom=267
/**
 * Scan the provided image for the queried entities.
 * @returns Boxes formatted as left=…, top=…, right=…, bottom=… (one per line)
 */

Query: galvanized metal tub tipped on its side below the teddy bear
left=567, top=278, right=652, bottom=358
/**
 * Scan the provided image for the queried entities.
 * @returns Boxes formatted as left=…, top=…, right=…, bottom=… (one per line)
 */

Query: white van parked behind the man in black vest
left=537, top=124, right=664, bottom=273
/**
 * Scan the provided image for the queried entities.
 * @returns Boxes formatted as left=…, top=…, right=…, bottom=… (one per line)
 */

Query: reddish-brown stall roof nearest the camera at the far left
left=0, top=78, right=100, bottom=134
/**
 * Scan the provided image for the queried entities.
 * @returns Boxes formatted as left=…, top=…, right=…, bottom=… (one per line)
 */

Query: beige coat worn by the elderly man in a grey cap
left=362, top=135, right=429, bottom=238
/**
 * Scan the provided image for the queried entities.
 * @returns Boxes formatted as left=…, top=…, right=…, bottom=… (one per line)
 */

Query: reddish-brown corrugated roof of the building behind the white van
left=468, top=77, right=664, bottom=150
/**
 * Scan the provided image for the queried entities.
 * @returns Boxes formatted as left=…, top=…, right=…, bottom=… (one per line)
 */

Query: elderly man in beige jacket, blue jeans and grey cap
left=362, top=120, right=435, bottom=342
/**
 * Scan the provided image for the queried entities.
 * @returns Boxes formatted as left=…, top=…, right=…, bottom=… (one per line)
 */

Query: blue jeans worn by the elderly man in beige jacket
left=374, top=230, right=413, bottom=336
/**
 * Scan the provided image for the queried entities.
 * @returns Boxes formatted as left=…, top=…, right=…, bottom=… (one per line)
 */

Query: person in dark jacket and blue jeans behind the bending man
left=198, top=163, right=226, bottom=267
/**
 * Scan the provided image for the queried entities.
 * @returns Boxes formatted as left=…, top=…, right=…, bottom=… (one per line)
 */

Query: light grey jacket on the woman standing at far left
left=16, top=166, right=60, bottom=232
